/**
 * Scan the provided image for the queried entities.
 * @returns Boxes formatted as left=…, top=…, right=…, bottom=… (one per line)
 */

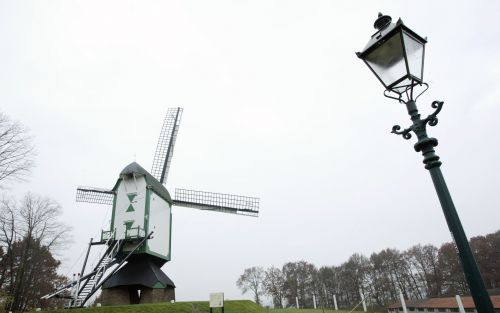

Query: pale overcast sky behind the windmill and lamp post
left=0, top=0, right=500, bottom=300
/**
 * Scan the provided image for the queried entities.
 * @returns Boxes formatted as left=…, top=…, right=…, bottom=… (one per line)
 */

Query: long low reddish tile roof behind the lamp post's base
left=388, top=295, right=500, bottom=309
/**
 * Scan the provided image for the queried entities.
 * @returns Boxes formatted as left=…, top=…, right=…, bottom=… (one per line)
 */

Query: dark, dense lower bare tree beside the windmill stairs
left=0, top=193, right=70, bottom=312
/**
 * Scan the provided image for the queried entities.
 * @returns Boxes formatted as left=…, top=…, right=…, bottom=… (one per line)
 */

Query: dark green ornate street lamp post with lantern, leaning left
left=356, top=13, right=494, bottom=313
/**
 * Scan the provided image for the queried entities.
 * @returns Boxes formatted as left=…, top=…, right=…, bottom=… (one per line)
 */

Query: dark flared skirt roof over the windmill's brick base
left=103, top=260, right=175, bottom=288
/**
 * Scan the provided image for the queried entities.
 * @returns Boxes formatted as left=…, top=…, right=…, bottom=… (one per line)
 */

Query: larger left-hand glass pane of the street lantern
left=365, top=32, right=407, bottom=87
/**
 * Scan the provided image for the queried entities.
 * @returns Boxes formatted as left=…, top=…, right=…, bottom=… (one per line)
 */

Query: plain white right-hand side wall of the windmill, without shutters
left=148, top=192, right=172, bottom=259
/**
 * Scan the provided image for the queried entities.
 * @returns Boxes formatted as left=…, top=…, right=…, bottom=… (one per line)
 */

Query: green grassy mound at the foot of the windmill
left=44, top=300, right=263, bottom=313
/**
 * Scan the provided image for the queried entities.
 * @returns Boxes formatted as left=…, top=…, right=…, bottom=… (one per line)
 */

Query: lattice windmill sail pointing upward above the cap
left=151, top=108, right=186, bottom=184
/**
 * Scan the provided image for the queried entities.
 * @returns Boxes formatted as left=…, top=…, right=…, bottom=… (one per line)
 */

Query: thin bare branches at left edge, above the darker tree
left=0, top=112, right=35, bottom=182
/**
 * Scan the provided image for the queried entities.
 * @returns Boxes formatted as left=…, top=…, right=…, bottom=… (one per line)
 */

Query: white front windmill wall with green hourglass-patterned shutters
left=113, top=176, right=146, bottom=239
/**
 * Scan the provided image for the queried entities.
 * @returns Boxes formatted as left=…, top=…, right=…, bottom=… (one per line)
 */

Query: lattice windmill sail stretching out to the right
left=173, top=188, right=259, bottom=217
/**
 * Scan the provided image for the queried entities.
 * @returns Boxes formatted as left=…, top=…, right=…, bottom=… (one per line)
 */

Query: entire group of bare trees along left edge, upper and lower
left=0, top=112, right=69, bottom=312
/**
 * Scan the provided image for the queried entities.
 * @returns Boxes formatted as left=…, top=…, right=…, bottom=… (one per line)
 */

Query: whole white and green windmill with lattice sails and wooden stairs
left=42, top=108, right=259, bottom=308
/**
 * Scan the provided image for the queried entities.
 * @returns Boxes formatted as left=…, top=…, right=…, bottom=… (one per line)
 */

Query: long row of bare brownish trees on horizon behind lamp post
left=236, top=230, right=500, bottom=309
